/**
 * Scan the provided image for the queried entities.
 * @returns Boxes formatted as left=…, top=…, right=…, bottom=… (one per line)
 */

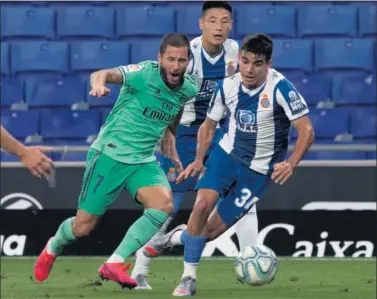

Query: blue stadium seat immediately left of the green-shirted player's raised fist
left=26, top=77, right=85, bottom=108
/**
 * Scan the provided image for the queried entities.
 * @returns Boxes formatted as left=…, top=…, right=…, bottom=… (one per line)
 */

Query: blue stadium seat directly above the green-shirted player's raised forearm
left=71, top=41, right=129, bottom=71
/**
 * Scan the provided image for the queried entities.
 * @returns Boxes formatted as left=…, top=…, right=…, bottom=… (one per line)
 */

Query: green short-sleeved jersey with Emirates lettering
left=91, top=61, right=198, bottom=164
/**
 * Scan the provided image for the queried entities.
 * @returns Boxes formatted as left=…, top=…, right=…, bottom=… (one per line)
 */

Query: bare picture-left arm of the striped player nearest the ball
left=177, top=116, right=218, bottom=184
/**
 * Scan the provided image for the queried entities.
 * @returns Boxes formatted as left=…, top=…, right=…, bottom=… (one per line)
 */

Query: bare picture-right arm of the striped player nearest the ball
left=271, top=115, right=315, bottom=185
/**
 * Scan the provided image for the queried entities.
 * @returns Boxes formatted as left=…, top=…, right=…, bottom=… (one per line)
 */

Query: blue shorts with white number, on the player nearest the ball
left=196, top=146, right=271, bottom=227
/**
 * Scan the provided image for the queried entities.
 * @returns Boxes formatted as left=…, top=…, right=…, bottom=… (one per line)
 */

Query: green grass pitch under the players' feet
left=1, top=257, right=376, bottom=299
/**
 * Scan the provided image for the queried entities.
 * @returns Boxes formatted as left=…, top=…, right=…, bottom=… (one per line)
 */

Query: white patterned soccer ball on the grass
left=235, top=245, right=278, bottom=286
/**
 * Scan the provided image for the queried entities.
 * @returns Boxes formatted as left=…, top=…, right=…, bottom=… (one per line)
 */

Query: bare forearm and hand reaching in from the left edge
left=1, top=126, right=53, bottom=178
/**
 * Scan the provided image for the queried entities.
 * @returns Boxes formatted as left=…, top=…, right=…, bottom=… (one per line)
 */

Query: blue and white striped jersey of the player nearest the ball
left=207, top=69, right=309, bottom=175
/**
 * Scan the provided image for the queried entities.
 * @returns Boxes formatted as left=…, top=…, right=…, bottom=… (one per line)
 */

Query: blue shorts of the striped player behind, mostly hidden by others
left=159, top=125, right=223, bottom=192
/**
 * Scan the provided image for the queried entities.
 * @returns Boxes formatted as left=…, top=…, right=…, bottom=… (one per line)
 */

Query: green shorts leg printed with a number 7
left=78, top=149, right=129, bottom=215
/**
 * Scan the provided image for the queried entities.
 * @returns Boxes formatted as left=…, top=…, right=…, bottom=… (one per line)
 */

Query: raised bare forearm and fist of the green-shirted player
left=89, top=68, right=123, bottom=97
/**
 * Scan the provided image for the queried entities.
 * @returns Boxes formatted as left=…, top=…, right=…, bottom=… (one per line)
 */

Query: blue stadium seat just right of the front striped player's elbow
left=292, top=108, right=350, bottom=140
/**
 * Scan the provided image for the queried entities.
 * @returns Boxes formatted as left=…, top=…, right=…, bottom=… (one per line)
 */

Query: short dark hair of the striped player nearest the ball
left=240, top=33, right=273, bottom=61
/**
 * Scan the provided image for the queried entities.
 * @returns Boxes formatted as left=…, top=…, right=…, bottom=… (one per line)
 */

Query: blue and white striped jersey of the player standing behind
left=181, top=36, right=239, bottom=126
